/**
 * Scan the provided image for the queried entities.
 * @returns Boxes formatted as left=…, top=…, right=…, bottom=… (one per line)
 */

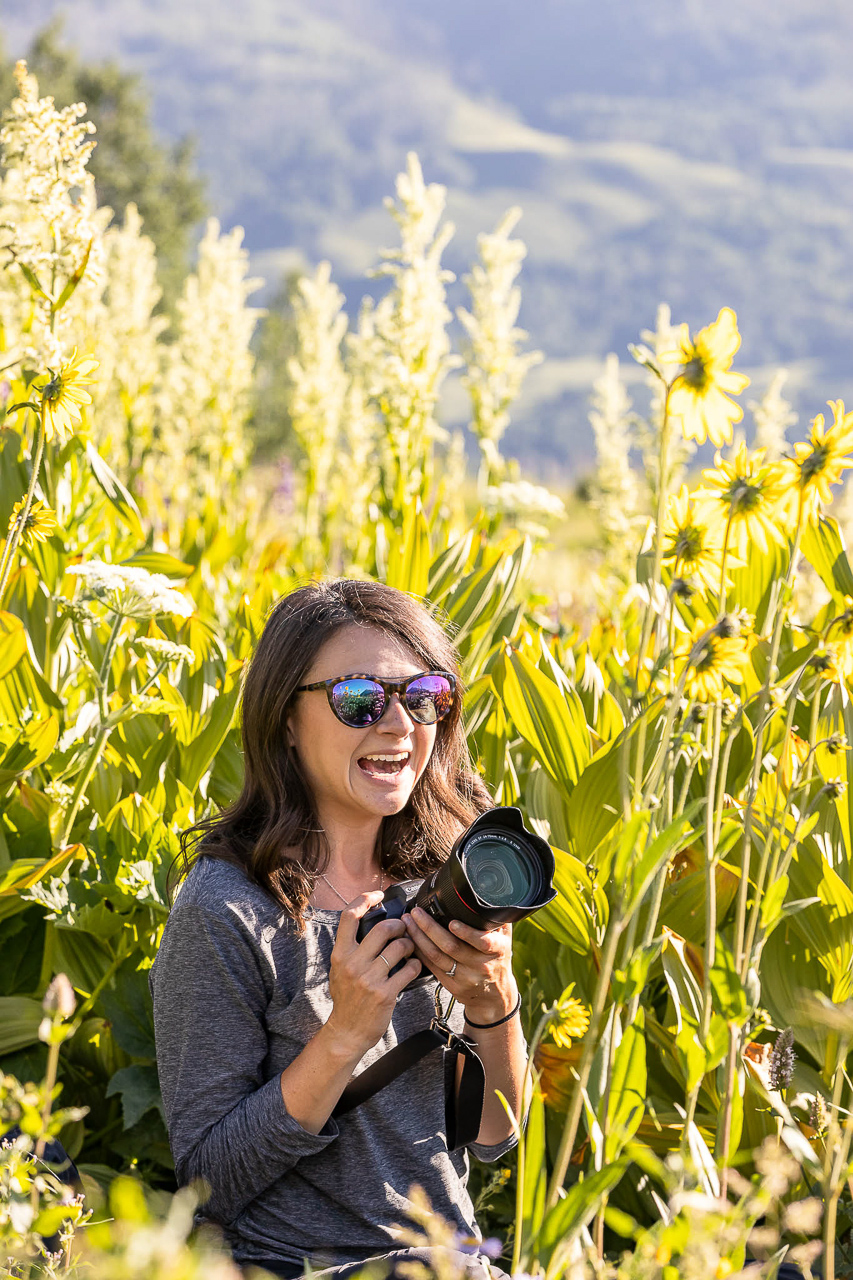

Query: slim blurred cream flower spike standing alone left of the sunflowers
left=589, top=352, right=642, bottom=577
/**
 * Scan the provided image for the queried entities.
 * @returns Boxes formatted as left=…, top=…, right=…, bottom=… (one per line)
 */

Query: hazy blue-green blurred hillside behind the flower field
left=0, top=0, right=853, bottom=471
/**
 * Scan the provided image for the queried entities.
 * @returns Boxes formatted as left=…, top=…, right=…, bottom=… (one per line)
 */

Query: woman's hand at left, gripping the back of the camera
left=327, top=890, right=420, bottom=1053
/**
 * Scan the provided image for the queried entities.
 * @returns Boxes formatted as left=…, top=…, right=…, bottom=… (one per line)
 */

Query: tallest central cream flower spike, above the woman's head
left=351, top=152, right=460, bottom=493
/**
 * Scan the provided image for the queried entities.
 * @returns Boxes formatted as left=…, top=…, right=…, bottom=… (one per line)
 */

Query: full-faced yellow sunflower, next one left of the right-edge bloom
left=694, top=442, right=786, bottom=558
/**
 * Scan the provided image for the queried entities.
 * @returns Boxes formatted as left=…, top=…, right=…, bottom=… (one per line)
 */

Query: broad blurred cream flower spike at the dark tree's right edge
left=151, top=218, right=263, bottom=515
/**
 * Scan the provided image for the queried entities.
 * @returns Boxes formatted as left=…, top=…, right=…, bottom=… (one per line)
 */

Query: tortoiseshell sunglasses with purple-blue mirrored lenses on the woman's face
left=296, top=671, right=456, bottom=728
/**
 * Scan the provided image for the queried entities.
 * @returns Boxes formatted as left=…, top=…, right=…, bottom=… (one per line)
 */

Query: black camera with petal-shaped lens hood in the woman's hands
left=356, top=805, right=557, bottom=987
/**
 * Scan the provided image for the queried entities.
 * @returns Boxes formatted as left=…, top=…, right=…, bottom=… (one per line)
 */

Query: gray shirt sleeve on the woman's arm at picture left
left=151, top=904, right=338, bottom=1226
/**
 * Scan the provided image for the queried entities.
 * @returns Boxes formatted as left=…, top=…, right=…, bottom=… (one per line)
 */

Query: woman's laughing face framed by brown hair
left=287, top=625, right=435, bottom=826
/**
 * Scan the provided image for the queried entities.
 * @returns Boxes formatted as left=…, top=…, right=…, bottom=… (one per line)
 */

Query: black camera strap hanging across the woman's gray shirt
left=332, top=992, right=485, bottom=1151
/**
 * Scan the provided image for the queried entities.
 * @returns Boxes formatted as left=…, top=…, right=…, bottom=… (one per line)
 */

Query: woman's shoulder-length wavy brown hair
left=175, top=579, right=493, bottom=928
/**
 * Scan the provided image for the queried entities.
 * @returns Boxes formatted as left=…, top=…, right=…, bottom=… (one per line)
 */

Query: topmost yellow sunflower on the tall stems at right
left=669, top=307, right=749, bottom=445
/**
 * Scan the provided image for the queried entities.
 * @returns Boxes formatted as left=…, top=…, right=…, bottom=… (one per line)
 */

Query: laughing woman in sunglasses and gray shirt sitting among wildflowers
left=151, top=580, right=525, bottom=1276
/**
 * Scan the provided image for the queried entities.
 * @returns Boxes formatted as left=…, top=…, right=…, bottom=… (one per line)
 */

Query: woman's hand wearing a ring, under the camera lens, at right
left=403, top=906, right=517, bottom=1023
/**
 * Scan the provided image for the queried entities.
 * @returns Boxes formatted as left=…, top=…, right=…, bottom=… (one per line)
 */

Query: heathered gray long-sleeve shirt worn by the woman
left=150, top=858, right=514, bottom=1266
